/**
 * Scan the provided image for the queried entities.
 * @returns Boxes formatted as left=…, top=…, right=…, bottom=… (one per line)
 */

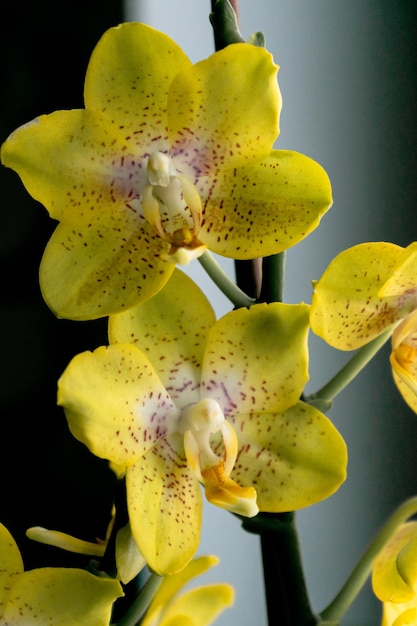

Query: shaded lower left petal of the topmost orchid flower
left=40, top=210, right=175, bottom=320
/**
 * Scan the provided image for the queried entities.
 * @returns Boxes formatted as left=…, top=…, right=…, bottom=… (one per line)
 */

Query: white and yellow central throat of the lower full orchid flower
left=181, top=398, right=259, bottom=517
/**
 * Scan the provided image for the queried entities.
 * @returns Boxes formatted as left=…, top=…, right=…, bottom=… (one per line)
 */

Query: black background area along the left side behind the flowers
left=0, top=0, right=123, bottom=568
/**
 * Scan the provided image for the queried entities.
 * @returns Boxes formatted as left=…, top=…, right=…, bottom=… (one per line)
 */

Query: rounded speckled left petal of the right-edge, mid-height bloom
left=310, top=242, right=403, bottom=350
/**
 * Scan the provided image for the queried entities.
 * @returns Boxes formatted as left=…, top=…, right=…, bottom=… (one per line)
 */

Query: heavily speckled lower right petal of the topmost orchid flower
left=197, top=150, right=332, bottom=259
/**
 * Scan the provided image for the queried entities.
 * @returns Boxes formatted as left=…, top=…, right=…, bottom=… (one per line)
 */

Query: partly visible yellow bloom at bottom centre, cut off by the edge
left=141, top=556, right=234, bottom=626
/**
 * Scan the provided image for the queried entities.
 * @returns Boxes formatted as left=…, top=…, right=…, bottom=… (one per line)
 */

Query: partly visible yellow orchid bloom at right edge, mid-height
left=310, top=242, right=417, bottom=412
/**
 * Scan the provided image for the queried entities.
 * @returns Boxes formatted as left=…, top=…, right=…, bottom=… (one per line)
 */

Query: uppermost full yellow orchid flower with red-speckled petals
left=1, top=23, right=332, bottom=319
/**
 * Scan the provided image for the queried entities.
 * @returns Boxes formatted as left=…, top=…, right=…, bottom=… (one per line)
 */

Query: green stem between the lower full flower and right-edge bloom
left=305, top=327, right=393, bottom=404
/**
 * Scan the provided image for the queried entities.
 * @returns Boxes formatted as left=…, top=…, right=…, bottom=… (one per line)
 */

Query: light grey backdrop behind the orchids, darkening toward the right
left=126, top=0, right=417, bottom=626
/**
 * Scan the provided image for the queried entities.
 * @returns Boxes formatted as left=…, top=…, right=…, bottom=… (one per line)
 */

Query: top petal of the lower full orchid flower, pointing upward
left=109, top=270, right=216, bottom=408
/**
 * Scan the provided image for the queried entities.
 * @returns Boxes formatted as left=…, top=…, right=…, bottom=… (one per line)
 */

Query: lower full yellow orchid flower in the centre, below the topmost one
left=58, top=270, right=346, bottom=575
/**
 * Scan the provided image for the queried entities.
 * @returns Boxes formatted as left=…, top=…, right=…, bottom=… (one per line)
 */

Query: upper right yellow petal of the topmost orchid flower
left=168, top=44, right=281, bottom=180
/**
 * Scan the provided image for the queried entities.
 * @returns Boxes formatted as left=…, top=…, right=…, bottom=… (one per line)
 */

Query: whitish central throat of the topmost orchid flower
left=142, top=151, right=206, bottom=265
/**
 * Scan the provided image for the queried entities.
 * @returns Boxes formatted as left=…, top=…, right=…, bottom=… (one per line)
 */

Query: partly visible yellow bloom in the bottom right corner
left=372, top=522, right=417, bottom=626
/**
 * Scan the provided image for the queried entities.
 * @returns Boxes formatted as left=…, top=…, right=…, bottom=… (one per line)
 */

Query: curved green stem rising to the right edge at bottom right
left=320, top=496, right=417, bottom=624
